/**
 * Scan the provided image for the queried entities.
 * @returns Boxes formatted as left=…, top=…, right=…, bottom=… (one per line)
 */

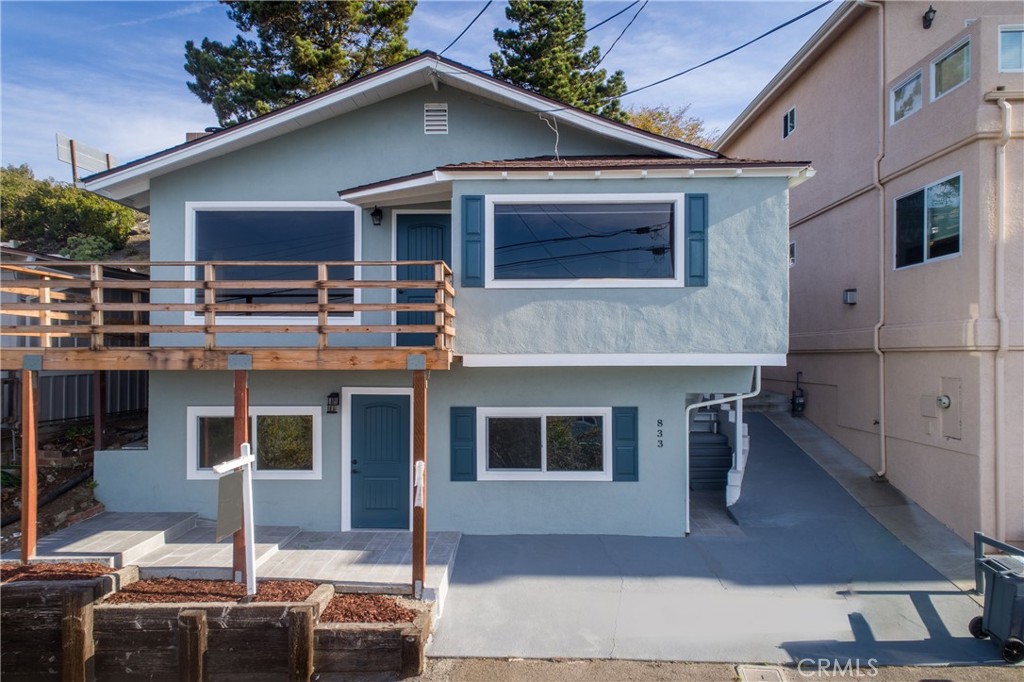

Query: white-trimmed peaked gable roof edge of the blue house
left=82, top=52, right=721, bottom=209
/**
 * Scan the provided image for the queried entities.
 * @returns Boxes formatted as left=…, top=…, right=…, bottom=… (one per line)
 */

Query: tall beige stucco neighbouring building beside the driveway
left=717, top=2, right=1024, bottom=542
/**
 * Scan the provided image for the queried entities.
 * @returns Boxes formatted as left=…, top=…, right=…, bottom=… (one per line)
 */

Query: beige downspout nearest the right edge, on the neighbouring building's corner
left=992, top=97, right=1011, bottom=540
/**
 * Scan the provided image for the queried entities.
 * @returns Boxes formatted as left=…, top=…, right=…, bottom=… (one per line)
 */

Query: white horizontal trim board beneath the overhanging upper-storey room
left=460, top=353, right=785, bottom=367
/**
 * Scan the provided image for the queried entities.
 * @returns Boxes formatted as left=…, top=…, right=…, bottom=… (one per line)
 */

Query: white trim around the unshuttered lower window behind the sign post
left=185, top=406, right=324, bottom=480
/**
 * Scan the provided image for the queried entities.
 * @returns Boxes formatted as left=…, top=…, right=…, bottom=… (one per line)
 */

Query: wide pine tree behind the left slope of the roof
left=185, top=0, right=416, bottom=126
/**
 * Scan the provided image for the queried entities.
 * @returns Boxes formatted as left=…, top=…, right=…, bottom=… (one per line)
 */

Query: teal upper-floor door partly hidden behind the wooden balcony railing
left=395, top=213, right=452, bottom=346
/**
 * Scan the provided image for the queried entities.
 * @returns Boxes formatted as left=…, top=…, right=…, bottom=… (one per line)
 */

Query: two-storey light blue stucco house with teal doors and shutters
left=79, top=53, right=812, bottom=536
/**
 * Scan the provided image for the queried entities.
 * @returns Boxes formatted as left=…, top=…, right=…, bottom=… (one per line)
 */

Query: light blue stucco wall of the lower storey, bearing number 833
left=95, top=368, right=752, bottom=536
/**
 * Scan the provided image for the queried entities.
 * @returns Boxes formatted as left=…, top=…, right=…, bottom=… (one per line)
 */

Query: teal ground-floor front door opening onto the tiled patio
left=350, top=395, right=410, bottom=530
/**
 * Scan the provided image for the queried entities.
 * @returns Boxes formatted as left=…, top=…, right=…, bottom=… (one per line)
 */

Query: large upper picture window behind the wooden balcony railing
left=185, top=202, right=358, bottom=324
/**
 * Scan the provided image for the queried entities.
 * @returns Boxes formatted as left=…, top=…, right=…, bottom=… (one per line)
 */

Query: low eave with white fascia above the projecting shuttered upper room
left=338, top=166, right=815, bottom=207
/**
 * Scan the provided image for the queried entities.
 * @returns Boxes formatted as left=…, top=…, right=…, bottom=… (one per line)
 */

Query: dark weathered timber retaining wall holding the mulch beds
left=0, top=572, right=431, bottom=682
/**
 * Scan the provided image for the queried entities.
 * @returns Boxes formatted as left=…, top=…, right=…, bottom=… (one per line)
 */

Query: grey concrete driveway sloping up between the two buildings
left=427, top=415, right=1001, bottom=669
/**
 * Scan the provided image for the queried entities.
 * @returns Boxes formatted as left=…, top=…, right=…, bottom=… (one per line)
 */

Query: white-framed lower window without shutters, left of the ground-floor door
left=187, top=407, right=321, bottom=478
